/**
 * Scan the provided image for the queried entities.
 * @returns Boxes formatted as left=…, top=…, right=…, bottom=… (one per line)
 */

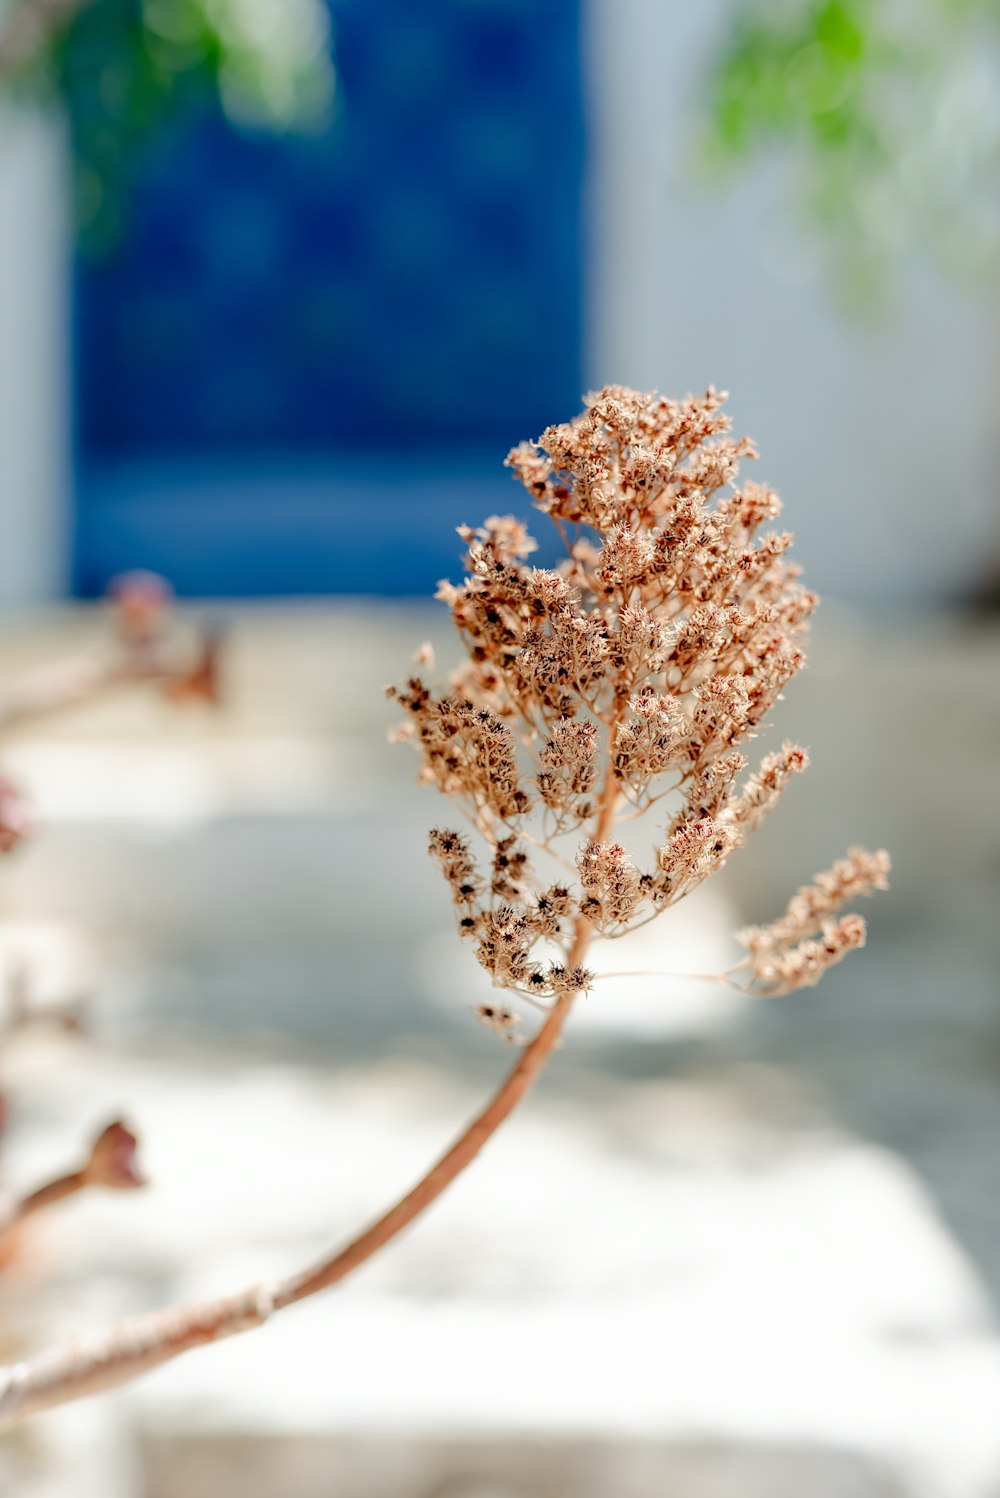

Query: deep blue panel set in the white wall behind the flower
left=76, top=0, right=584, bottom=595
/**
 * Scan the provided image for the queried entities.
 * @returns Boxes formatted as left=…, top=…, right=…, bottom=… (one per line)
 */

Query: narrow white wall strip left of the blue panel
left=0, top=105, right=70, bottom=608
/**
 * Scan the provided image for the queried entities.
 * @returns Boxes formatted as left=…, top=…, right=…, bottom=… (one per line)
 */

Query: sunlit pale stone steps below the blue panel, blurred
left=0, top=605, right=1000, bottom=1498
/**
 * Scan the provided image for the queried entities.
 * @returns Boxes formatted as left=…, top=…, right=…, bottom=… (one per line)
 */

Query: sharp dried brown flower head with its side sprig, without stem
left=389, top=386, right=889, bottom=1037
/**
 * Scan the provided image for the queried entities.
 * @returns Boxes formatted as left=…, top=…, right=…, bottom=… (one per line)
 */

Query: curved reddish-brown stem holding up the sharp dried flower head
left=0, top=740, right=618, bottom=1426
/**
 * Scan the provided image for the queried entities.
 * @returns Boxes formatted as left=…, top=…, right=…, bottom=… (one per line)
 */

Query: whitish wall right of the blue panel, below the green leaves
left=587, top=0, right=1000, bottom=601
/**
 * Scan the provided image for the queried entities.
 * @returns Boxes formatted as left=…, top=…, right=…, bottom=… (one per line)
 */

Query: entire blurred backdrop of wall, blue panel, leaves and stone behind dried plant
left=0, top=0, right=1000, bottom=1498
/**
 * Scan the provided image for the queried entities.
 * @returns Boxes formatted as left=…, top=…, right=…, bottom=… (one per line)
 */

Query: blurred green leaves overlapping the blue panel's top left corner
left=0, top=0, right=334, bottom=252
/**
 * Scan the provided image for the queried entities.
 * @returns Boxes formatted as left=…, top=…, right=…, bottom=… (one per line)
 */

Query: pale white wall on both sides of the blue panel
left=7, top=0, right=1000, bottom=608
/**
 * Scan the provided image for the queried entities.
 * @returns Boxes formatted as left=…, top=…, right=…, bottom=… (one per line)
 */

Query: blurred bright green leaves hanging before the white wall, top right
left=705, top=0, right=1000, bottom=298
